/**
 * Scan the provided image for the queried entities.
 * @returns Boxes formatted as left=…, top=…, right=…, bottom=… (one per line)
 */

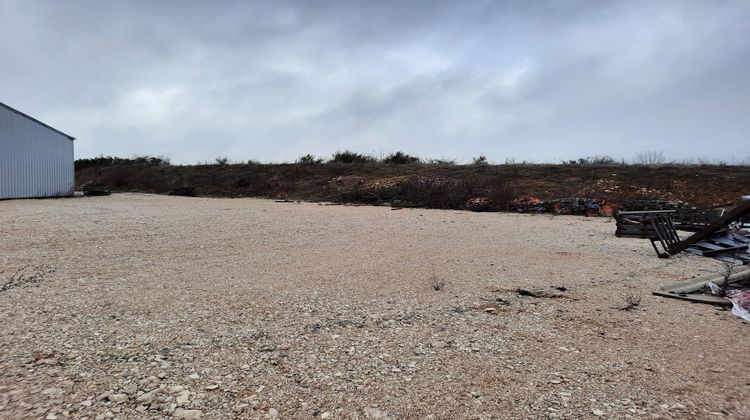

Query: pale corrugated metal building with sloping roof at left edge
left=0, top=102, right=75, bottom=199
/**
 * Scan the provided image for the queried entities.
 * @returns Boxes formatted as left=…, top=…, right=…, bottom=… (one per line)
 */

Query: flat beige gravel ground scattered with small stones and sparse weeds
left=0, top=194, right=750, bottom=420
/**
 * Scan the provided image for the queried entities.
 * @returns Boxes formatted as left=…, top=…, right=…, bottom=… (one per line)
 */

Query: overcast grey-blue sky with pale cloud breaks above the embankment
left=0, top=0, right=750, bottom=163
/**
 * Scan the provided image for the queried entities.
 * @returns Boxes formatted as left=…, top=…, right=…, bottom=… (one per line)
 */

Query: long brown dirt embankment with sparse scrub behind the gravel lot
left=76, top=163, right=750, bottom=210
